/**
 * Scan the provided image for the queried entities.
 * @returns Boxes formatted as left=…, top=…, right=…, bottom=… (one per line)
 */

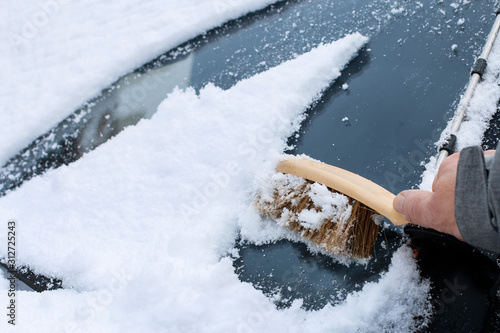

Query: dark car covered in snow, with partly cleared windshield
left=0, top=0, right=500, bottom=332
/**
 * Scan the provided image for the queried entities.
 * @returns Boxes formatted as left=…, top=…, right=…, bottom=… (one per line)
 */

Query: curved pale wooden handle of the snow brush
left=276, top=158, right=408, bottom=225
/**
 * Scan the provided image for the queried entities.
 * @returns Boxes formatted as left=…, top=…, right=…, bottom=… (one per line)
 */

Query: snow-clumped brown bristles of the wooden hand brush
left=255, top=174, right=378, bottom=258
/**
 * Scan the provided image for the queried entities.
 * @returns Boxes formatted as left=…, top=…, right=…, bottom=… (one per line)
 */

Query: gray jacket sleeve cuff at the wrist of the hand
left=455, top=146, right=500, bottom=253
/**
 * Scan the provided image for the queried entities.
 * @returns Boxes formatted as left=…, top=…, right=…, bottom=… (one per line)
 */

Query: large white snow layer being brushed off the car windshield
left=0, top=29, right=429, bottom=332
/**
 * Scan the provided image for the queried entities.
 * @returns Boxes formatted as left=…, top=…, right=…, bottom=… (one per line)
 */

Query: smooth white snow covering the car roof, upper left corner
left=0, top=0, right=276, bottom=165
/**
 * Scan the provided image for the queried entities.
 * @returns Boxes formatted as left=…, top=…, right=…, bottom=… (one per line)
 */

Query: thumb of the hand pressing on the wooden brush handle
left=392, top=190, right=432, bottom=226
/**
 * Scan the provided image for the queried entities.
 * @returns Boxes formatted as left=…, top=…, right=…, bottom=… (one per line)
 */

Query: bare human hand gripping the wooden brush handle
left=393, top=150, right=495, bottom=241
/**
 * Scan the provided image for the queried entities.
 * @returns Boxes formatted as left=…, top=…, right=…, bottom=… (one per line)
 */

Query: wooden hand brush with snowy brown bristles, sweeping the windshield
left=254, top=157, right=408, bottom=259
